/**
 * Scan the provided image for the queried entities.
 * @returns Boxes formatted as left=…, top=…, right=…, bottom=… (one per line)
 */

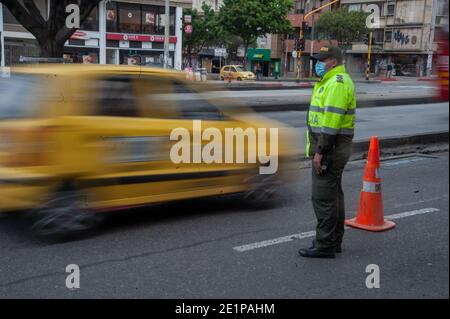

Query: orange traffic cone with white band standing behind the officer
left=345, top=136, right=395, bottom=231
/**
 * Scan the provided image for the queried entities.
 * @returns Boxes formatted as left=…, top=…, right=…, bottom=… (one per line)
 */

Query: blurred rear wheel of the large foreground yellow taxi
left=30, top=191, right=104, bottom=240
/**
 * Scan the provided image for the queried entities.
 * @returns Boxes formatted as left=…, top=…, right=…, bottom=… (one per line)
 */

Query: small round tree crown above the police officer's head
left=316, top=8, right=369, bottom=49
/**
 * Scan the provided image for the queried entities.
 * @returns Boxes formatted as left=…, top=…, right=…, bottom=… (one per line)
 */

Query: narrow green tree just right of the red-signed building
left=183, top=2, right=224, bottom=65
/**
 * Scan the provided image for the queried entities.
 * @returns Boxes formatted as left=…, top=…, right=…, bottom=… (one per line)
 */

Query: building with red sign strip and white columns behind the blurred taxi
left=0, top=0, right=192, bottom=69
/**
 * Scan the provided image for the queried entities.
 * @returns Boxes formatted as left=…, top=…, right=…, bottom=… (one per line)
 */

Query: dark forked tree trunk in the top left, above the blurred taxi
left=0, top=0, right=100, bottom=58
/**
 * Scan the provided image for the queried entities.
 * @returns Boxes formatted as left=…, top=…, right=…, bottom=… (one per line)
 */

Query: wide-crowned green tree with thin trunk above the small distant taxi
left=220, top=0, right=293, bottom=65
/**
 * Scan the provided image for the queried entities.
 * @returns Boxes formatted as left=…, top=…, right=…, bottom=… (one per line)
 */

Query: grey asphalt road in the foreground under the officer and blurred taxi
left=0, top=153, right=449, bottom=298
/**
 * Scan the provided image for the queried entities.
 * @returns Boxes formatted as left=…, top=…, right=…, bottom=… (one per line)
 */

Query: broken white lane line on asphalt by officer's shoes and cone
left=233, top=208, right=440, bottom=253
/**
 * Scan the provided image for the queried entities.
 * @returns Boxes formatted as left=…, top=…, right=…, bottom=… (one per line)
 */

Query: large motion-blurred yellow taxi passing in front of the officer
left=0, top=65, right=297, bottom=237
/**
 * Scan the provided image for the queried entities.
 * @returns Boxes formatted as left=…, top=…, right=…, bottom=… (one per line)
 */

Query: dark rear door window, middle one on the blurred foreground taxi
left=96, top=76, right=138, bottom=117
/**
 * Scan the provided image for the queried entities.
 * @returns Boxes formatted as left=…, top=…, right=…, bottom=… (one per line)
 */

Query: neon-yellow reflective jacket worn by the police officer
left=306, top=65, right=356, bottom=157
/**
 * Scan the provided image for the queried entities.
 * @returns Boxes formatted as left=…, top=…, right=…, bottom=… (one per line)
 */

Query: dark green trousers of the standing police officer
left=312, top=141, right=352, bottom=248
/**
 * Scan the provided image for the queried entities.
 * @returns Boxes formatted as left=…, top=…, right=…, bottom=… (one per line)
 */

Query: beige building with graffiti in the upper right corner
left=341, top=0, right=448, bottom=76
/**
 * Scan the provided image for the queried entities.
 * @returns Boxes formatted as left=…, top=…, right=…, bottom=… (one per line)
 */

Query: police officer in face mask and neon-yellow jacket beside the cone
left=299, top=46, right=356, bottom=258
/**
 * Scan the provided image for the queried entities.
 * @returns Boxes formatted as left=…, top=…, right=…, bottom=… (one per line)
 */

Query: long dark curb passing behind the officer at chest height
left=248, top=96, right=437, bottom=112
